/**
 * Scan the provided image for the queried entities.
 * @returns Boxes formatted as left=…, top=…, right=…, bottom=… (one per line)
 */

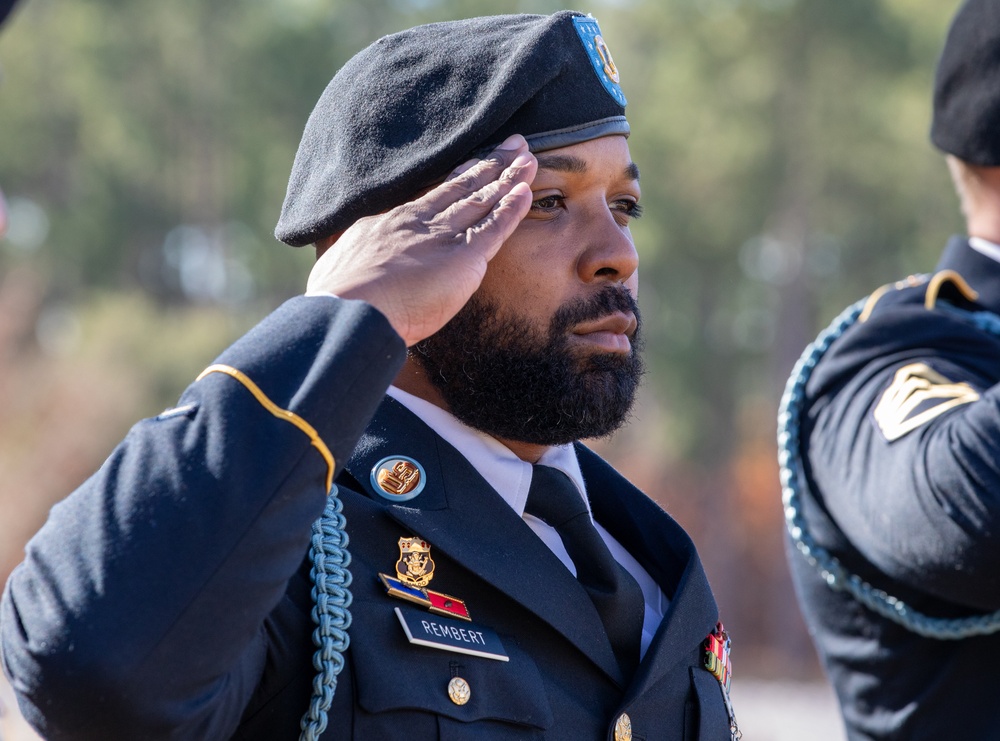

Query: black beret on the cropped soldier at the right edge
left=931, top=0, right=1000, bottom=167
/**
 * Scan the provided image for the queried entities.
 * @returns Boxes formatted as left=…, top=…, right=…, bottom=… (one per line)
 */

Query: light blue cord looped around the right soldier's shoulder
left=778, top=299, right=1000, bottom=640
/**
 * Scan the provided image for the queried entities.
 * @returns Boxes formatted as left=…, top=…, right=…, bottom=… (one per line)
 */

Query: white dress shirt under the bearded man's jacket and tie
left=388, top=386, right=669, bottom=655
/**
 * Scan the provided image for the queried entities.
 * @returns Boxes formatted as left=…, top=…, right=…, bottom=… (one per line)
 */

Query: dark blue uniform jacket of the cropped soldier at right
left=789, top=238, right=1000, bottom=741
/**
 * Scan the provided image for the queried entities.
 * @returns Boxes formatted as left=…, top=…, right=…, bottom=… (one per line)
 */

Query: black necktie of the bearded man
left=524, top=466, right=645, bottom=681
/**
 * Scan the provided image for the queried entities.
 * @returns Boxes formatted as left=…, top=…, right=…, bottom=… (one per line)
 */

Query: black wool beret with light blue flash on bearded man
left=275, top=11, right=629, bottom=247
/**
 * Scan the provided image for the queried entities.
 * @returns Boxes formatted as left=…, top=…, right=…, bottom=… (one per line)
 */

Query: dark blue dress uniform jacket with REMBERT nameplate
left=0, top=298, right=729, bottom=741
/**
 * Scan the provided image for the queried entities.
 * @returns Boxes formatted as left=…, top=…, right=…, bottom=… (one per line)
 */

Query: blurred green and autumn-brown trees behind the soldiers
left=0, top=0, right=961, bottom=678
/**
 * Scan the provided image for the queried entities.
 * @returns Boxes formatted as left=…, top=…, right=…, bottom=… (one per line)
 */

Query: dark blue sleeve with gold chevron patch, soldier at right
left=806, top=307, right=1000, bottom=611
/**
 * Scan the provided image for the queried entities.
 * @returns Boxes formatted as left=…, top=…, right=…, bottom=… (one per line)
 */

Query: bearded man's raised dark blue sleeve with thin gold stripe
left=0, top=297, right=405, bottom=741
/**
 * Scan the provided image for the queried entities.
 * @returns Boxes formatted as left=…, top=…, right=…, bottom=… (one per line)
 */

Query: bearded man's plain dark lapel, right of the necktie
left=577, top=444, right=719, bottom=702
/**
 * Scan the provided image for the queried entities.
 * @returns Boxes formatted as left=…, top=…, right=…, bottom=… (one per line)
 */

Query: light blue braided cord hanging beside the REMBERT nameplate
left=299, top=484, right=351, bottom=741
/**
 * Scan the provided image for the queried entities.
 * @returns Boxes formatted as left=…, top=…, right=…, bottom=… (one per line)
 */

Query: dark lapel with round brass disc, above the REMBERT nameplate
left=346, top=398, right=622, bottom=684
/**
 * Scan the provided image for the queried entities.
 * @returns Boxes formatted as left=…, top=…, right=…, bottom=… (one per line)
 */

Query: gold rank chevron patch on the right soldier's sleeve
left=874, top=363, right=979, bottom=442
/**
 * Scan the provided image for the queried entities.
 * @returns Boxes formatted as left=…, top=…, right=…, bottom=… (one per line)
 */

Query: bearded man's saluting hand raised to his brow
left=306, top=135, right=538, bottom=347
